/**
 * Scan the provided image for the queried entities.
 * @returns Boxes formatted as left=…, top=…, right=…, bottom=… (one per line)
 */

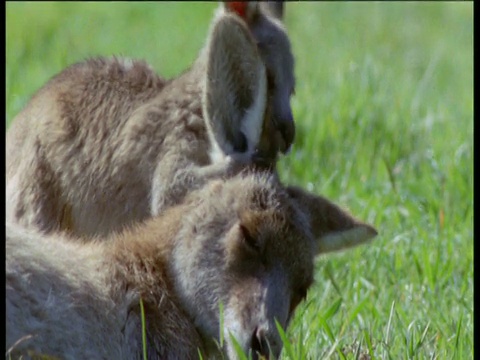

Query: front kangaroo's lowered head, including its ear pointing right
left=172, top=173, right=376, bottom=359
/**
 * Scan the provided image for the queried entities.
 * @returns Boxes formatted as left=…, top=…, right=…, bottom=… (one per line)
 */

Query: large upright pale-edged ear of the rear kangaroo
left=203, top=13, right=267, bottom=159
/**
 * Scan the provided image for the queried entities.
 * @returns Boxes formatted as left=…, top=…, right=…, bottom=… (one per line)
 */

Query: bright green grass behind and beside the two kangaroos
left=6, top=2, right=473, bottom=359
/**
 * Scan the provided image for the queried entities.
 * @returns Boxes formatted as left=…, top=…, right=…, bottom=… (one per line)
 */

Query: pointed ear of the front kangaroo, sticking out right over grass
left=287, top=186, right=378, bottom=254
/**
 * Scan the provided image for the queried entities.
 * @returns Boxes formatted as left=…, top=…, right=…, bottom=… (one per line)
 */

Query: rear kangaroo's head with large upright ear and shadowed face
left=203, top=2, right=295, bottom=168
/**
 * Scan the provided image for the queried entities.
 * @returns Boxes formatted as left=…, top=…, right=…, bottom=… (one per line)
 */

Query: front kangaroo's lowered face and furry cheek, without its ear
left=173, top=184, right=314, bottom=359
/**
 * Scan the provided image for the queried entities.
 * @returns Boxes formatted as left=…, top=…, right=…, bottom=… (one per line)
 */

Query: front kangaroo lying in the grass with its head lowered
left=5, top=173, right=376, bottom=359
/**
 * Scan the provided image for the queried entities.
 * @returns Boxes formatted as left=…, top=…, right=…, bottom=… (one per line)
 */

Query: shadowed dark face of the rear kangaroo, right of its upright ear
left=224, top=1, right=295, bottom=152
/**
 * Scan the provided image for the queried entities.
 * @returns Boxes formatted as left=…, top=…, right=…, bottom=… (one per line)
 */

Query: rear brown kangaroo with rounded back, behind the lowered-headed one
left=6, top=5, right=293, bottom=236
